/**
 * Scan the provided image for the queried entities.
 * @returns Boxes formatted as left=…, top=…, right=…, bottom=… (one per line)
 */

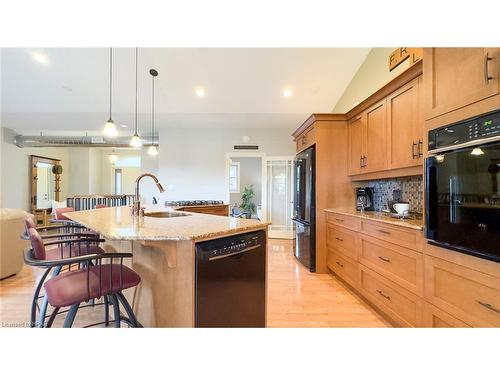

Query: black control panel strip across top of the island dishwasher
left=196, top=231, right=265, bottom=260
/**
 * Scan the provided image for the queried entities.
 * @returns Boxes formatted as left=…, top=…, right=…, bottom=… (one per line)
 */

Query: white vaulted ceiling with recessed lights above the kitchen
left=1, top=48, right=369, bottom=132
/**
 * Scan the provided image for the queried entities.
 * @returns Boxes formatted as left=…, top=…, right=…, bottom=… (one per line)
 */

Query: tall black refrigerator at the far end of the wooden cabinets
left=292, top=146, right=316, bottom=272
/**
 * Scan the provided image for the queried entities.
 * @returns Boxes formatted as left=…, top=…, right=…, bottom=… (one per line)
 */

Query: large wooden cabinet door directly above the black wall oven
left=424, top=48, right=499, bottom=119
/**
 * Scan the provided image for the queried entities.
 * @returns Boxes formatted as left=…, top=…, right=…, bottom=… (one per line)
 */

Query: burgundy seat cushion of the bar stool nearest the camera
left=44, top=264, right=141, bottom=307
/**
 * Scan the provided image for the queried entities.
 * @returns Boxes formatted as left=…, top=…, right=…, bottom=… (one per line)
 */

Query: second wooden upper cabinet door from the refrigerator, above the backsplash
left=363, top=99, right=388, bottom=173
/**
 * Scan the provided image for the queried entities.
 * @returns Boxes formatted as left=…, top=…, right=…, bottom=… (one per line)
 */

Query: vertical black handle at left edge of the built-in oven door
left=425, top=156, right=438, bottom=240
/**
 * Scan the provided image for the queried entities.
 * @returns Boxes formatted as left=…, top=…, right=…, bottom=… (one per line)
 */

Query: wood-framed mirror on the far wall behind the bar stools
left=30, top=155, right=62, bottom=214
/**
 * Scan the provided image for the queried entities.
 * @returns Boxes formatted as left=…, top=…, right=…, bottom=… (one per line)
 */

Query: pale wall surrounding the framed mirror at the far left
left=0, top=128, right=69, bottom=211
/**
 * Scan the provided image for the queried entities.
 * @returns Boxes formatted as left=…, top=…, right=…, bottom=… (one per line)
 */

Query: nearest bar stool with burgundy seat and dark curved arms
left=24, top=228, right=142, bottom=328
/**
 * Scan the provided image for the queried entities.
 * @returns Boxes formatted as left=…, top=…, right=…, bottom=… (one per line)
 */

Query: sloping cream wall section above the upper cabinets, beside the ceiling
left=333, top=47, right=409, bottom=113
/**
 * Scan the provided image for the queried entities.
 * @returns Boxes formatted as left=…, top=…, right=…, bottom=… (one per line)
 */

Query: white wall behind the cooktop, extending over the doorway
left=158, top=124, right=299, bottom=203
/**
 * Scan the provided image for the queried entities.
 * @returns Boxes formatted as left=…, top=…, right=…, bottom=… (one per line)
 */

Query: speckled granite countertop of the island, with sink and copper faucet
left=65, top=206, right=270, bottom=241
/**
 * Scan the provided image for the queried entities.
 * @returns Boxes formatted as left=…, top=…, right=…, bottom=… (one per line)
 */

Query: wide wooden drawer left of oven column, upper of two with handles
left=358, top=234, right=424, bottom=296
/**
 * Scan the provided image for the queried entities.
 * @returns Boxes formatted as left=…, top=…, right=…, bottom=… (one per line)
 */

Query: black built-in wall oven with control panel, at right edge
left=425, top=111, right=500, bottom=262
